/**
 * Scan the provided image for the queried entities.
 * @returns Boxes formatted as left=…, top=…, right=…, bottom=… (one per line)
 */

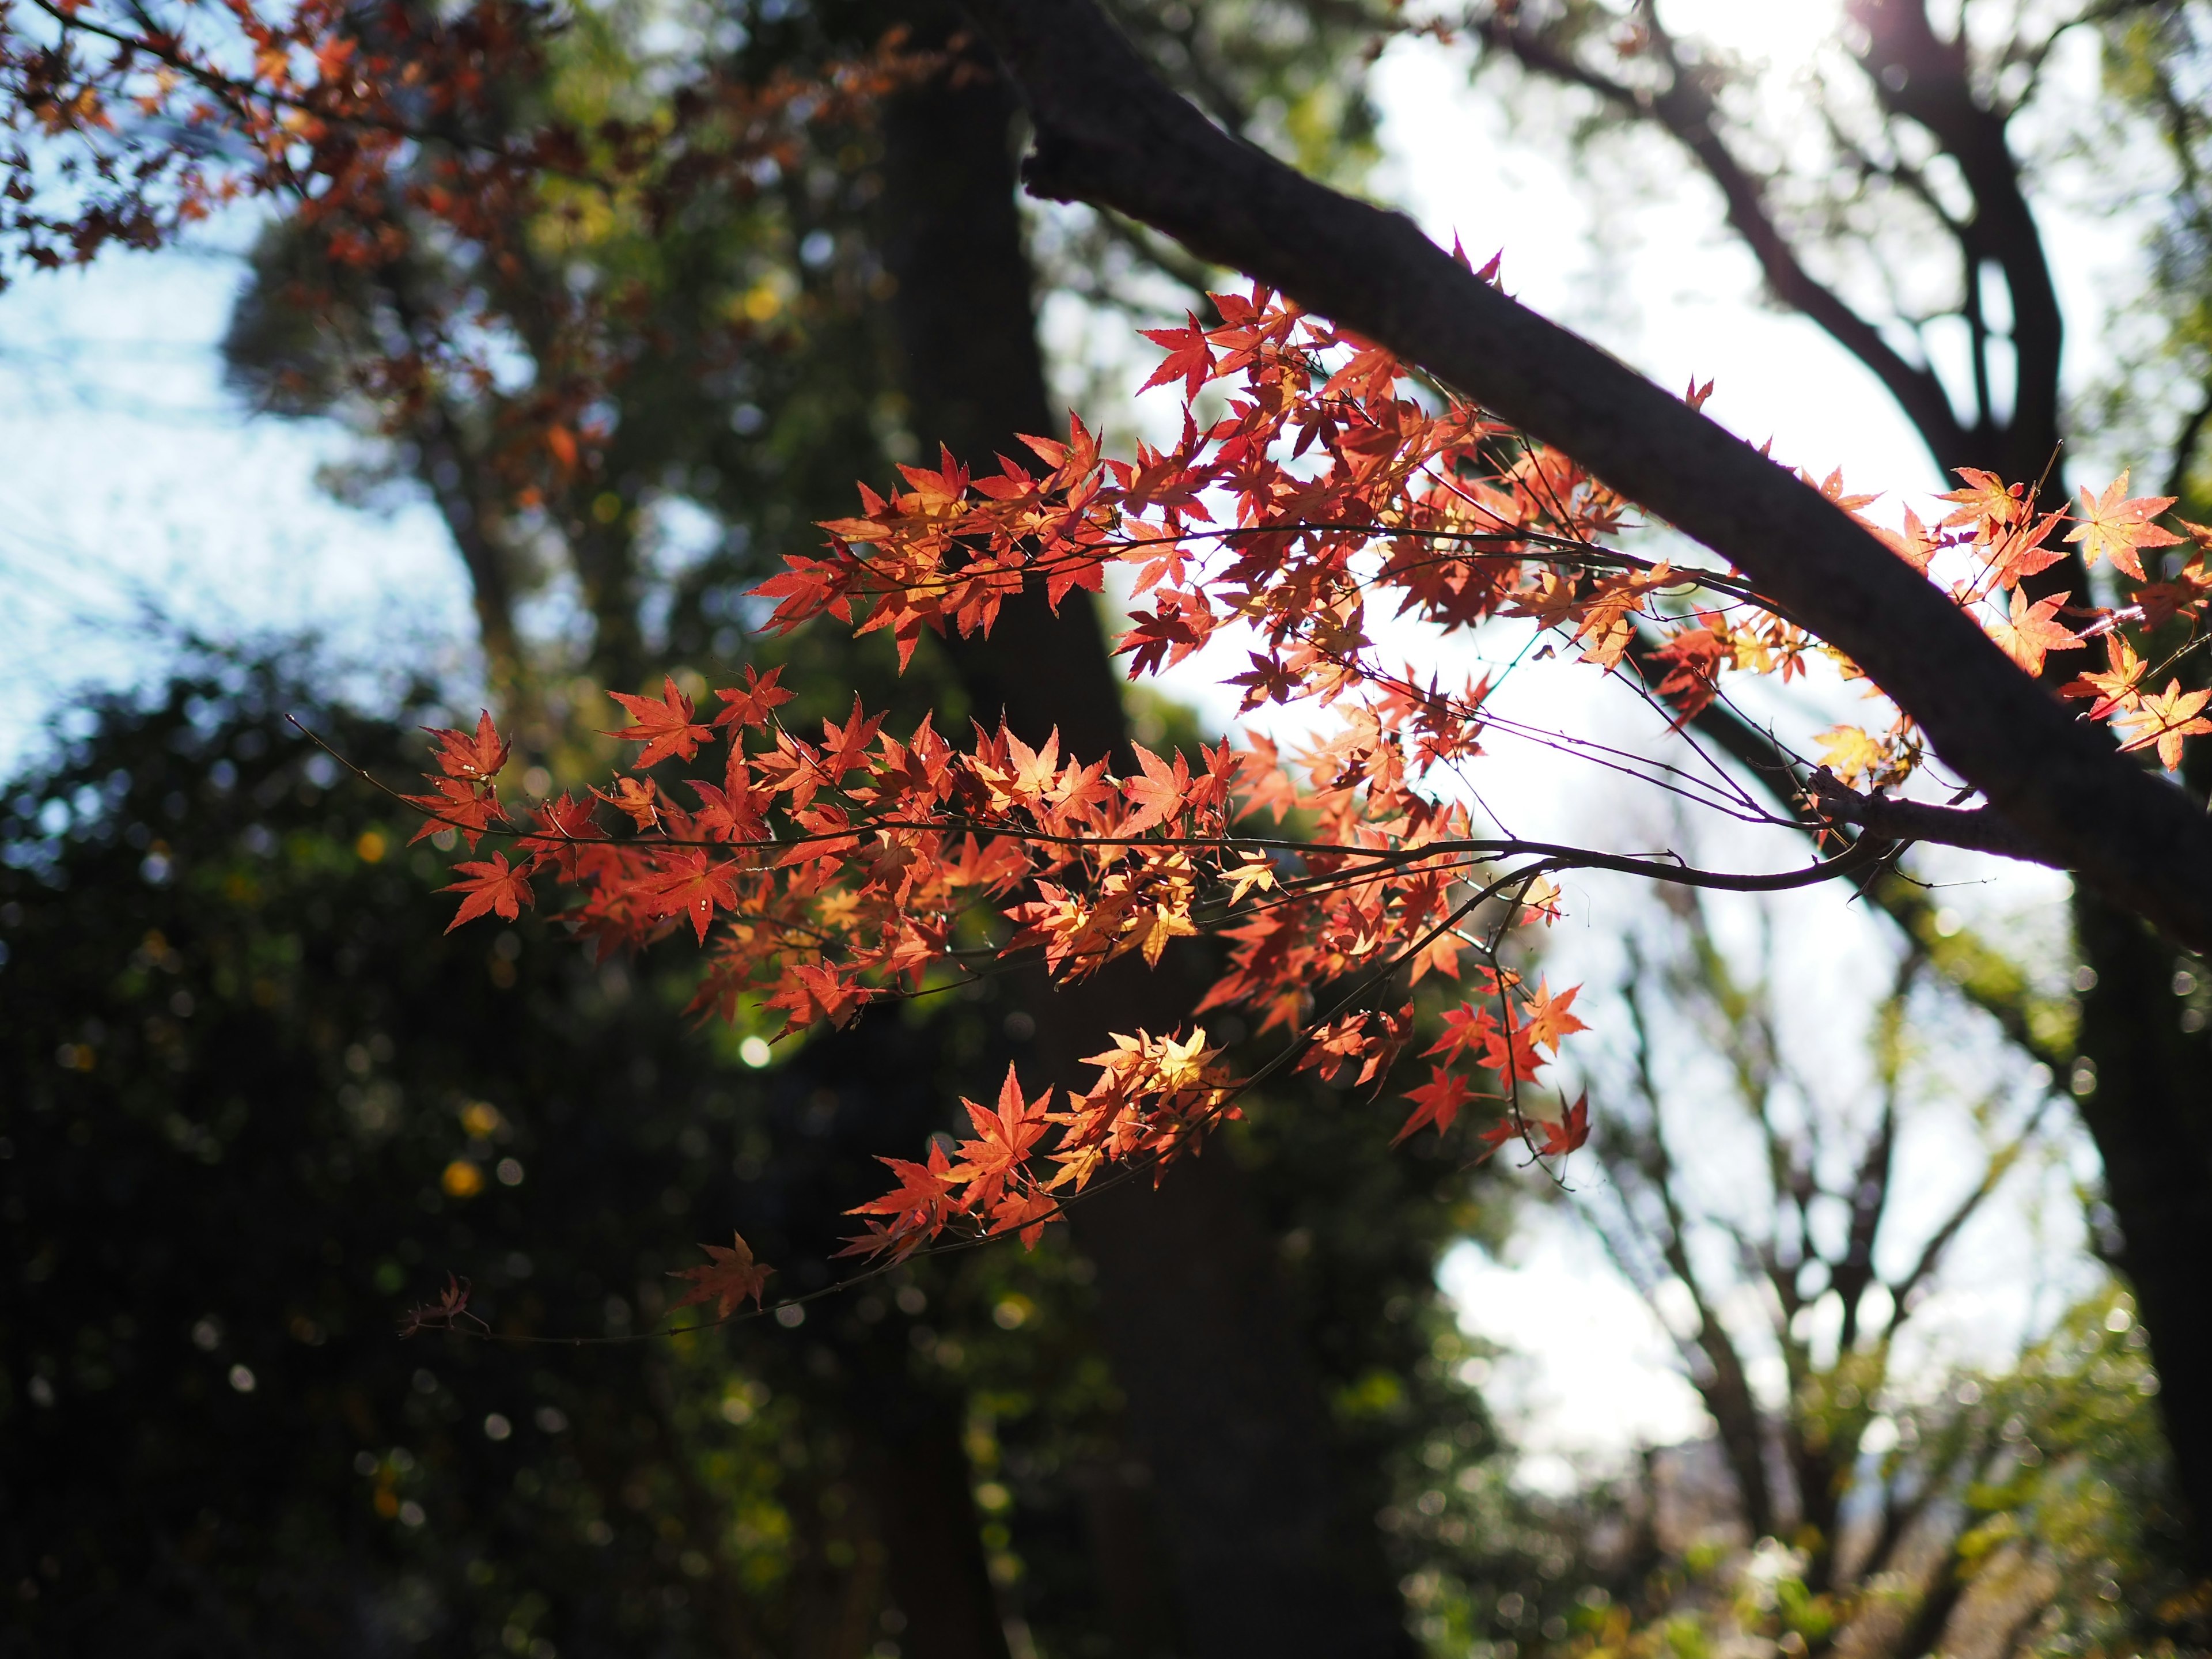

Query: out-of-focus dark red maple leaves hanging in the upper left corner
left=0, top=0, right=945, bottom=493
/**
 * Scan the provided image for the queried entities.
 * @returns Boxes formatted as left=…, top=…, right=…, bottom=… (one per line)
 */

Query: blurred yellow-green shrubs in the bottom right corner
left=1521, top=1287, right=2212, bottom=1659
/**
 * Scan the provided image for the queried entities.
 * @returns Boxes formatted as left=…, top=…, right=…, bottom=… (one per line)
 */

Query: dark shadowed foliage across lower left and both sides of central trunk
left=0, top=661, right=1531, bottom=1659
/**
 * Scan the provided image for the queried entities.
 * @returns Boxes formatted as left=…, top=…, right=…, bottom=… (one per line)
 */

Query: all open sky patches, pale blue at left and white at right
left=0, top=0, right=2164, bottom=1478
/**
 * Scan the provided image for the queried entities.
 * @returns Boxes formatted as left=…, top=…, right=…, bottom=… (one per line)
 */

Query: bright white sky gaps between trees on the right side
left=1378, top=0, right=2115, bottom=1482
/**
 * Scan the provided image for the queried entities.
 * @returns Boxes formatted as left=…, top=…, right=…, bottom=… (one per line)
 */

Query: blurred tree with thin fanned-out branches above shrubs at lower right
left=1539, top=898, right=2205, bottom=1659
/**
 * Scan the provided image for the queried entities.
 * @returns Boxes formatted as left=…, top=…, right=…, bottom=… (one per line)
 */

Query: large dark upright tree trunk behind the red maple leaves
left=880, top=16, right=1411, bottom=1659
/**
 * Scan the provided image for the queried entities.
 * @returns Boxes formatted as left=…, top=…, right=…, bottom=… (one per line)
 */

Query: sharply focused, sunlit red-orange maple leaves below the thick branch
left=411, top=279, right=2212, bottom=1312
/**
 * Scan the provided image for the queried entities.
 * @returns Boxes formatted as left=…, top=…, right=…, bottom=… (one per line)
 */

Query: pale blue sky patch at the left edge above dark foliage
left=0, top=245, right=471, bottom=774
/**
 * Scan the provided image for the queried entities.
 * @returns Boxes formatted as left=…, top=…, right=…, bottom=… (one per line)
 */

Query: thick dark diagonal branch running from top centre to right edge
left=971, top=0, right=2212, bottom=949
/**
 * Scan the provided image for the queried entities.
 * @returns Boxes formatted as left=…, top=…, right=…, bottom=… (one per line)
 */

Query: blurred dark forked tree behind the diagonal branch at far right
left=1464, top=0, right=2212, bottom=1569
